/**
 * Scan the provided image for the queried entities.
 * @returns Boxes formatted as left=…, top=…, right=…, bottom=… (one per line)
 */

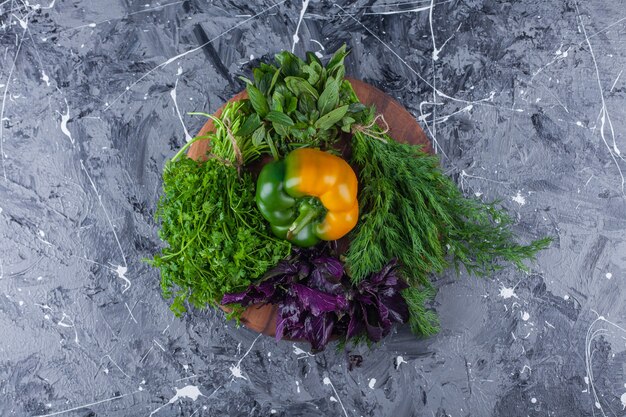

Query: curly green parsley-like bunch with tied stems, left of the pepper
left=151, top=103, right=291, bottom=315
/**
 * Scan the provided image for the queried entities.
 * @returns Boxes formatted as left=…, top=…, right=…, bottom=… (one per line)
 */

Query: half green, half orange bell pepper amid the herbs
left=256, top=148, right=359, bottom=247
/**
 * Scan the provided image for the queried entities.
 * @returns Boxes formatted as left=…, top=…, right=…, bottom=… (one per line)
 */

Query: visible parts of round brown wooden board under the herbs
left=187, top=78, right=432, bottom=336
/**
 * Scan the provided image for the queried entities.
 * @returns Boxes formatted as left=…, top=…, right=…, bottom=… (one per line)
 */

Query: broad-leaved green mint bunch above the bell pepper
left=242, top=45, right=360, bottom=159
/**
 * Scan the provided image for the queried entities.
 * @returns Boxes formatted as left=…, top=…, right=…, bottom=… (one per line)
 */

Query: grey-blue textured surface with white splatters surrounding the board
left=0, top=0, right=626, bottom=417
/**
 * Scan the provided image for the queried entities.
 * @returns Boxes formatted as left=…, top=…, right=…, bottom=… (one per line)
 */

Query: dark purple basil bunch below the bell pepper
left=222, top=246, right=409, bottom=351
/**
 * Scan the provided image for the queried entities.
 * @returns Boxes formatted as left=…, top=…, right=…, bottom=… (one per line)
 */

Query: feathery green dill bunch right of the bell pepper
left=346, top=128, right=551, bottom=289
